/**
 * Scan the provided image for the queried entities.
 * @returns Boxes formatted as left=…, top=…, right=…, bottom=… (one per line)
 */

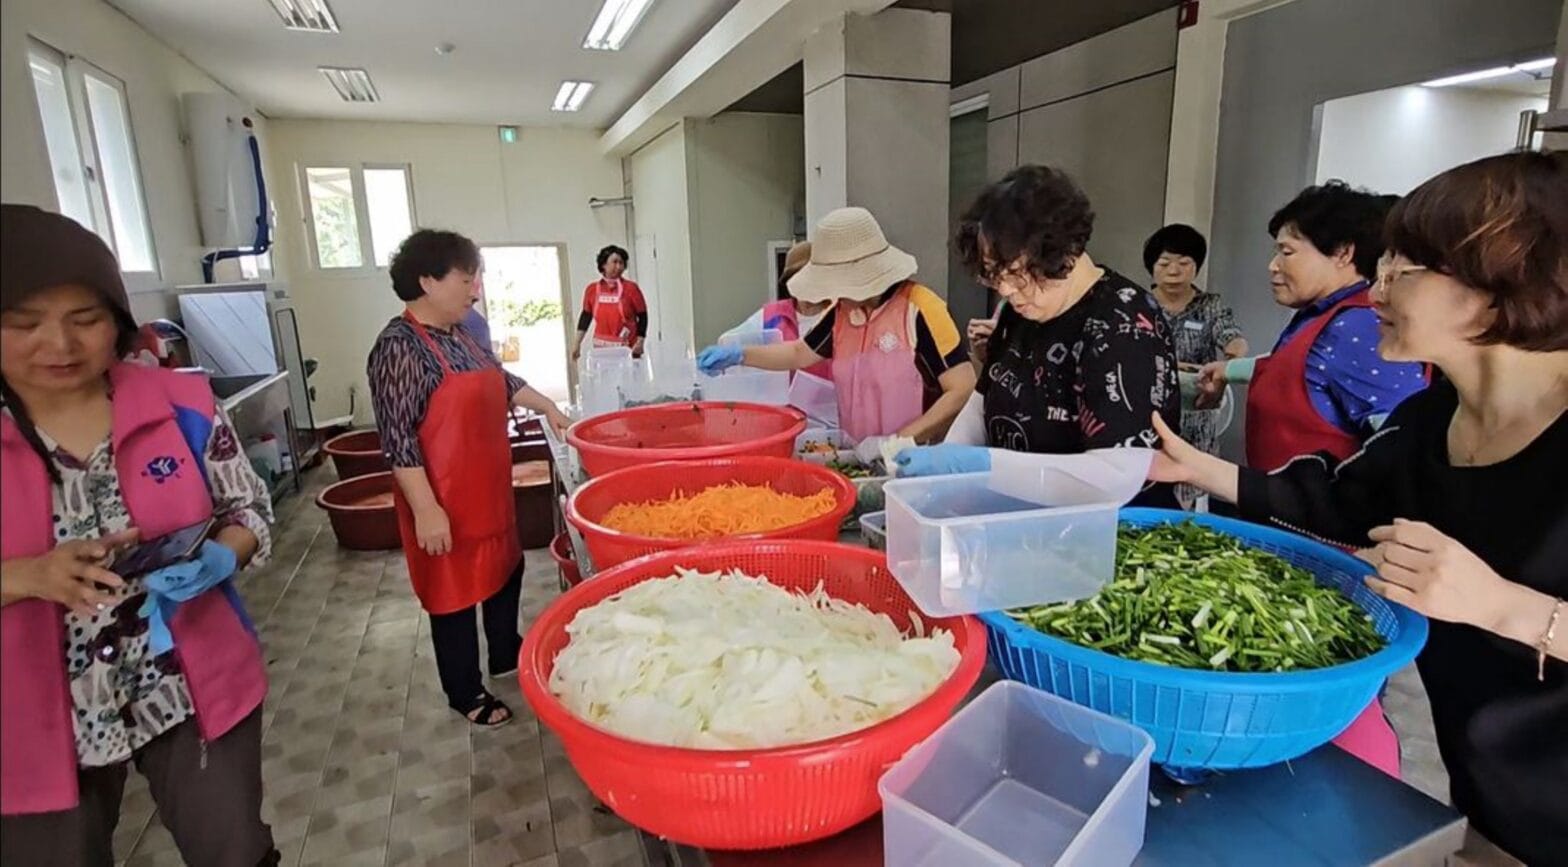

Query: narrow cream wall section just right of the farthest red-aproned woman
left=626, top=121, right=693, bottom=343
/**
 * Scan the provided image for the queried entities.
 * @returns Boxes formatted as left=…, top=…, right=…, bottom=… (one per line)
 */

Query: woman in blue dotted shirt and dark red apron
left=1200, top=183, right=1427, bottom=776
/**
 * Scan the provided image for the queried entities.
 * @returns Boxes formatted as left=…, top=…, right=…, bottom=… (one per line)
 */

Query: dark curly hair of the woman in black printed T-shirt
left=953, top=166, right=1094, bottom=284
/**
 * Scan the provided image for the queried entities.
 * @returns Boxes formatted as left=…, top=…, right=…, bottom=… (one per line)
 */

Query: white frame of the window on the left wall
left=27, top=36, right=163, bottom=280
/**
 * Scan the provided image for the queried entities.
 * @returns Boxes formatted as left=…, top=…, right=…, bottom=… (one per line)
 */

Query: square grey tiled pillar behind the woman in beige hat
left=804, top=9, right=952, bottom=296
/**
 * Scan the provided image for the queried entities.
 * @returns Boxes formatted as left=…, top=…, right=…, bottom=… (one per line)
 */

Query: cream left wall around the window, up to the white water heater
left=0, top=0, right=254, bottom=318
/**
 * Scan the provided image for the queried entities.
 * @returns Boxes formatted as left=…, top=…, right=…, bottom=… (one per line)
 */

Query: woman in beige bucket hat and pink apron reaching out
left=698, top=207, right=975, bottom=442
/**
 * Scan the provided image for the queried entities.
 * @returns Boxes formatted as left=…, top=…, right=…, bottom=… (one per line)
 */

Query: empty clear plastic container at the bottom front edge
left=877, top=680, right=1154, bottom=867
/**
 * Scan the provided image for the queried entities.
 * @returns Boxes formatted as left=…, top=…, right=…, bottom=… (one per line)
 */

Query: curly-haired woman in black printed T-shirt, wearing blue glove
left=897, top=166, right=1181, bottom=508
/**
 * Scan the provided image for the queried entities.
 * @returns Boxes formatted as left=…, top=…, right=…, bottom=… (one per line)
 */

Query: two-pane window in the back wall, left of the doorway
left=304, top=165, right=414, bottom=270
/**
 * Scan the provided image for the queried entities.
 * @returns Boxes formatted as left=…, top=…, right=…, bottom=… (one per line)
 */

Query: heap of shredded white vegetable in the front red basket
left=549, top=569, right=958, bottom=749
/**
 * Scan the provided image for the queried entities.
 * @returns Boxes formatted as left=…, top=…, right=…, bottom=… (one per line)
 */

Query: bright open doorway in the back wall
left=480, top=245, right=571, bottom=403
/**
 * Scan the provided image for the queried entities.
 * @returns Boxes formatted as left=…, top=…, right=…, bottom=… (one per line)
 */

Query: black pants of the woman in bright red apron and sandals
left=430, top=557, right=522, bottom=712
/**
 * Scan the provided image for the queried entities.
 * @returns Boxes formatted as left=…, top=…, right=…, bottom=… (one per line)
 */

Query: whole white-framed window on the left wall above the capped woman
left=28, top=42, right=158, bottom=273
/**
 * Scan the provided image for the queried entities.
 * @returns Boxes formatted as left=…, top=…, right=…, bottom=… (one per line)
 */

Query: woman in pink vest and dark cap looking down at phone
left=0, top=205, right=279, bottom=867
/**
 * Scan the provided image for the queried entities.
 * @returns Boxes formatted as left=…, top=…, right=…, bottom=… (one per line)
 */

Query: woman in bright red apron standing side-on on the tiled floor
left=368, top=229, right=568, bottom=726
